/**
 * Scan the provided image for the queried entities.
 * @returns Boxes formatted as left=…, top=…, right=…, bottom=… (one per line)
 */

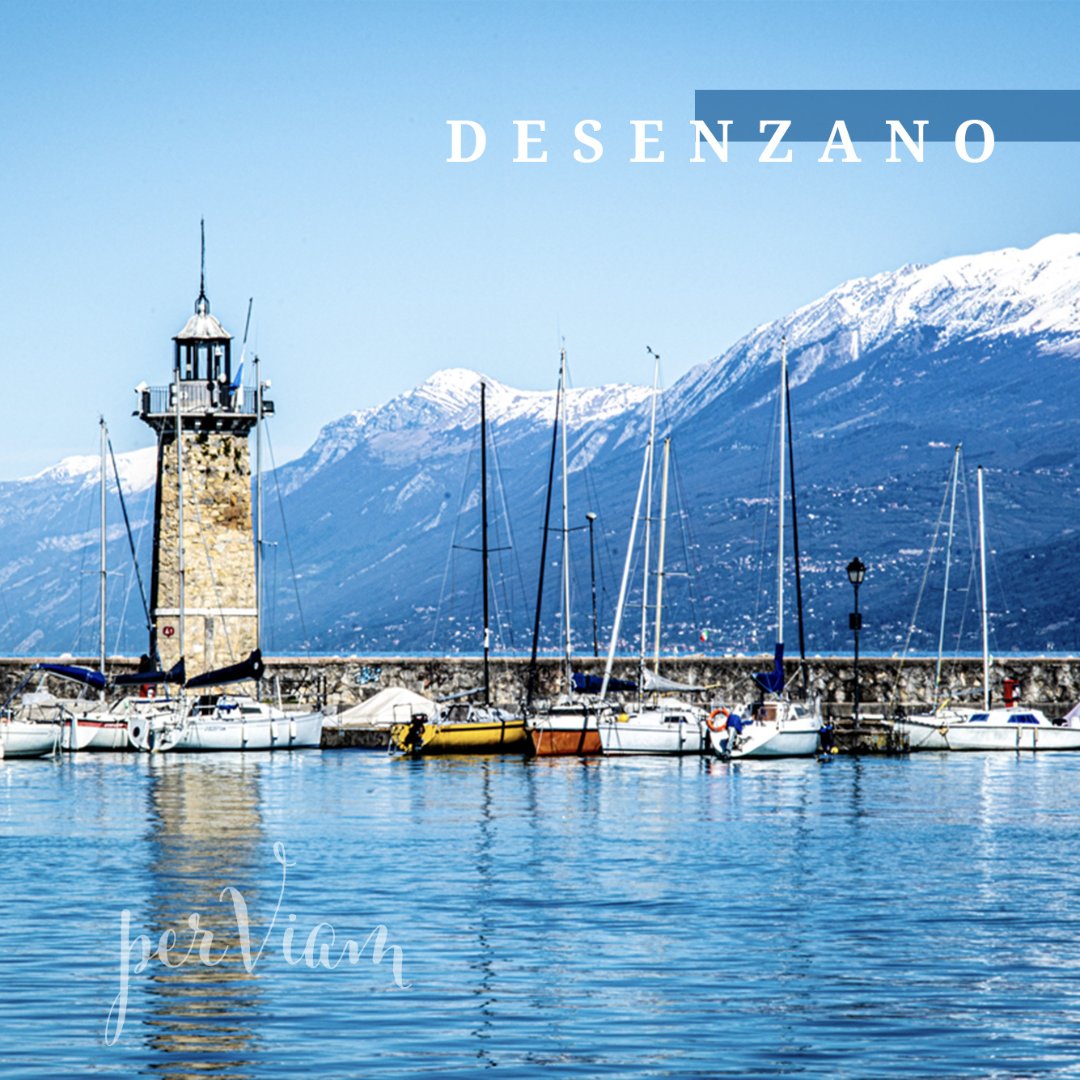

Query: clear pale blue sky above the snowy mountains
left=0, top=0, right=1080, bottom=478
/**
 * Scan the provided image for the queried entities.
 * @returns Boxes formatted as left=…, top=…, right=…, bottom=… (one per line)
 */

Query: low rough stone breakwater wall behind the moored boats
left=0, top=656, right=1080, bottom=719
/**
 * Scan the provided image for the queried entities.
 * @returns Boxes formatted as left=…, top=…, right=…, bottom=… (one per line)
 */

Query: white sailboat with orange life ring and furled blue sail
left=707, top=338, right=822, bottom=758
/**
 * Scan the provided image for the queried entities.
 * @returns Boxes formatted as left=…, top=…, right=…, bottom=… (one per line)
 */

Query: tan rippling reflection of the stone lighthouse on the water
left=144, top=754, right=266, bottom=1080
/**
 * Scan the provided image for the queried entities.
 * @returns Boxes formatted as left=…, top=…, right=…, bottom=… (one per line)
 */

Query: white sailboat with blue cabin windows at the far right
left=893, top=468, right=1080, bottom=751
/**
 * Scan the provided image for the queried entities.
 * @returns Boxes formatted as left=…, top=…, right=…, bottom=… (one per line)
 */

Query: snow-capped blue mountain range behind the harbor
left=0, top=234, right=1080, bottom=652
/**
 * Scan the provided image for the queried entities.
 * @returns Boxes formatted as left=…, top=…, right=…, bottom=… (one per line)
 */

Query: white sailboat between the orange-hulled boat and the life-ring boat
left=598, top=349, right=708, bottom=755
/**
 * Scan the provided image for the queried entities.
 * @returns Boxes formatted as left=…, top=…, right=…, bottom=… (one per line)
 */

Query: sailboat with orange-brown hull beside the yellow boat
left=526, top=348, right=603, bottom=757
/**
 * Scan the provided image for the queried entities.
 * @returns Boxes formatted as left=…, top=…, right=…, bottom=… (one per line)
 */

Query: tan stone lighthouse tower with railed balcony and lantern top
left=137, top=248, right=272, bottom=675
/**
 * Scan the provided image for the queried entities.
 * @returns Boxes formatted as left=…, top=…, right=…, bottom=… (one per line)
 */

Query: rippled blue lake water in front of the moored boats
left=0, top=752, right=1080, bottom=1080
